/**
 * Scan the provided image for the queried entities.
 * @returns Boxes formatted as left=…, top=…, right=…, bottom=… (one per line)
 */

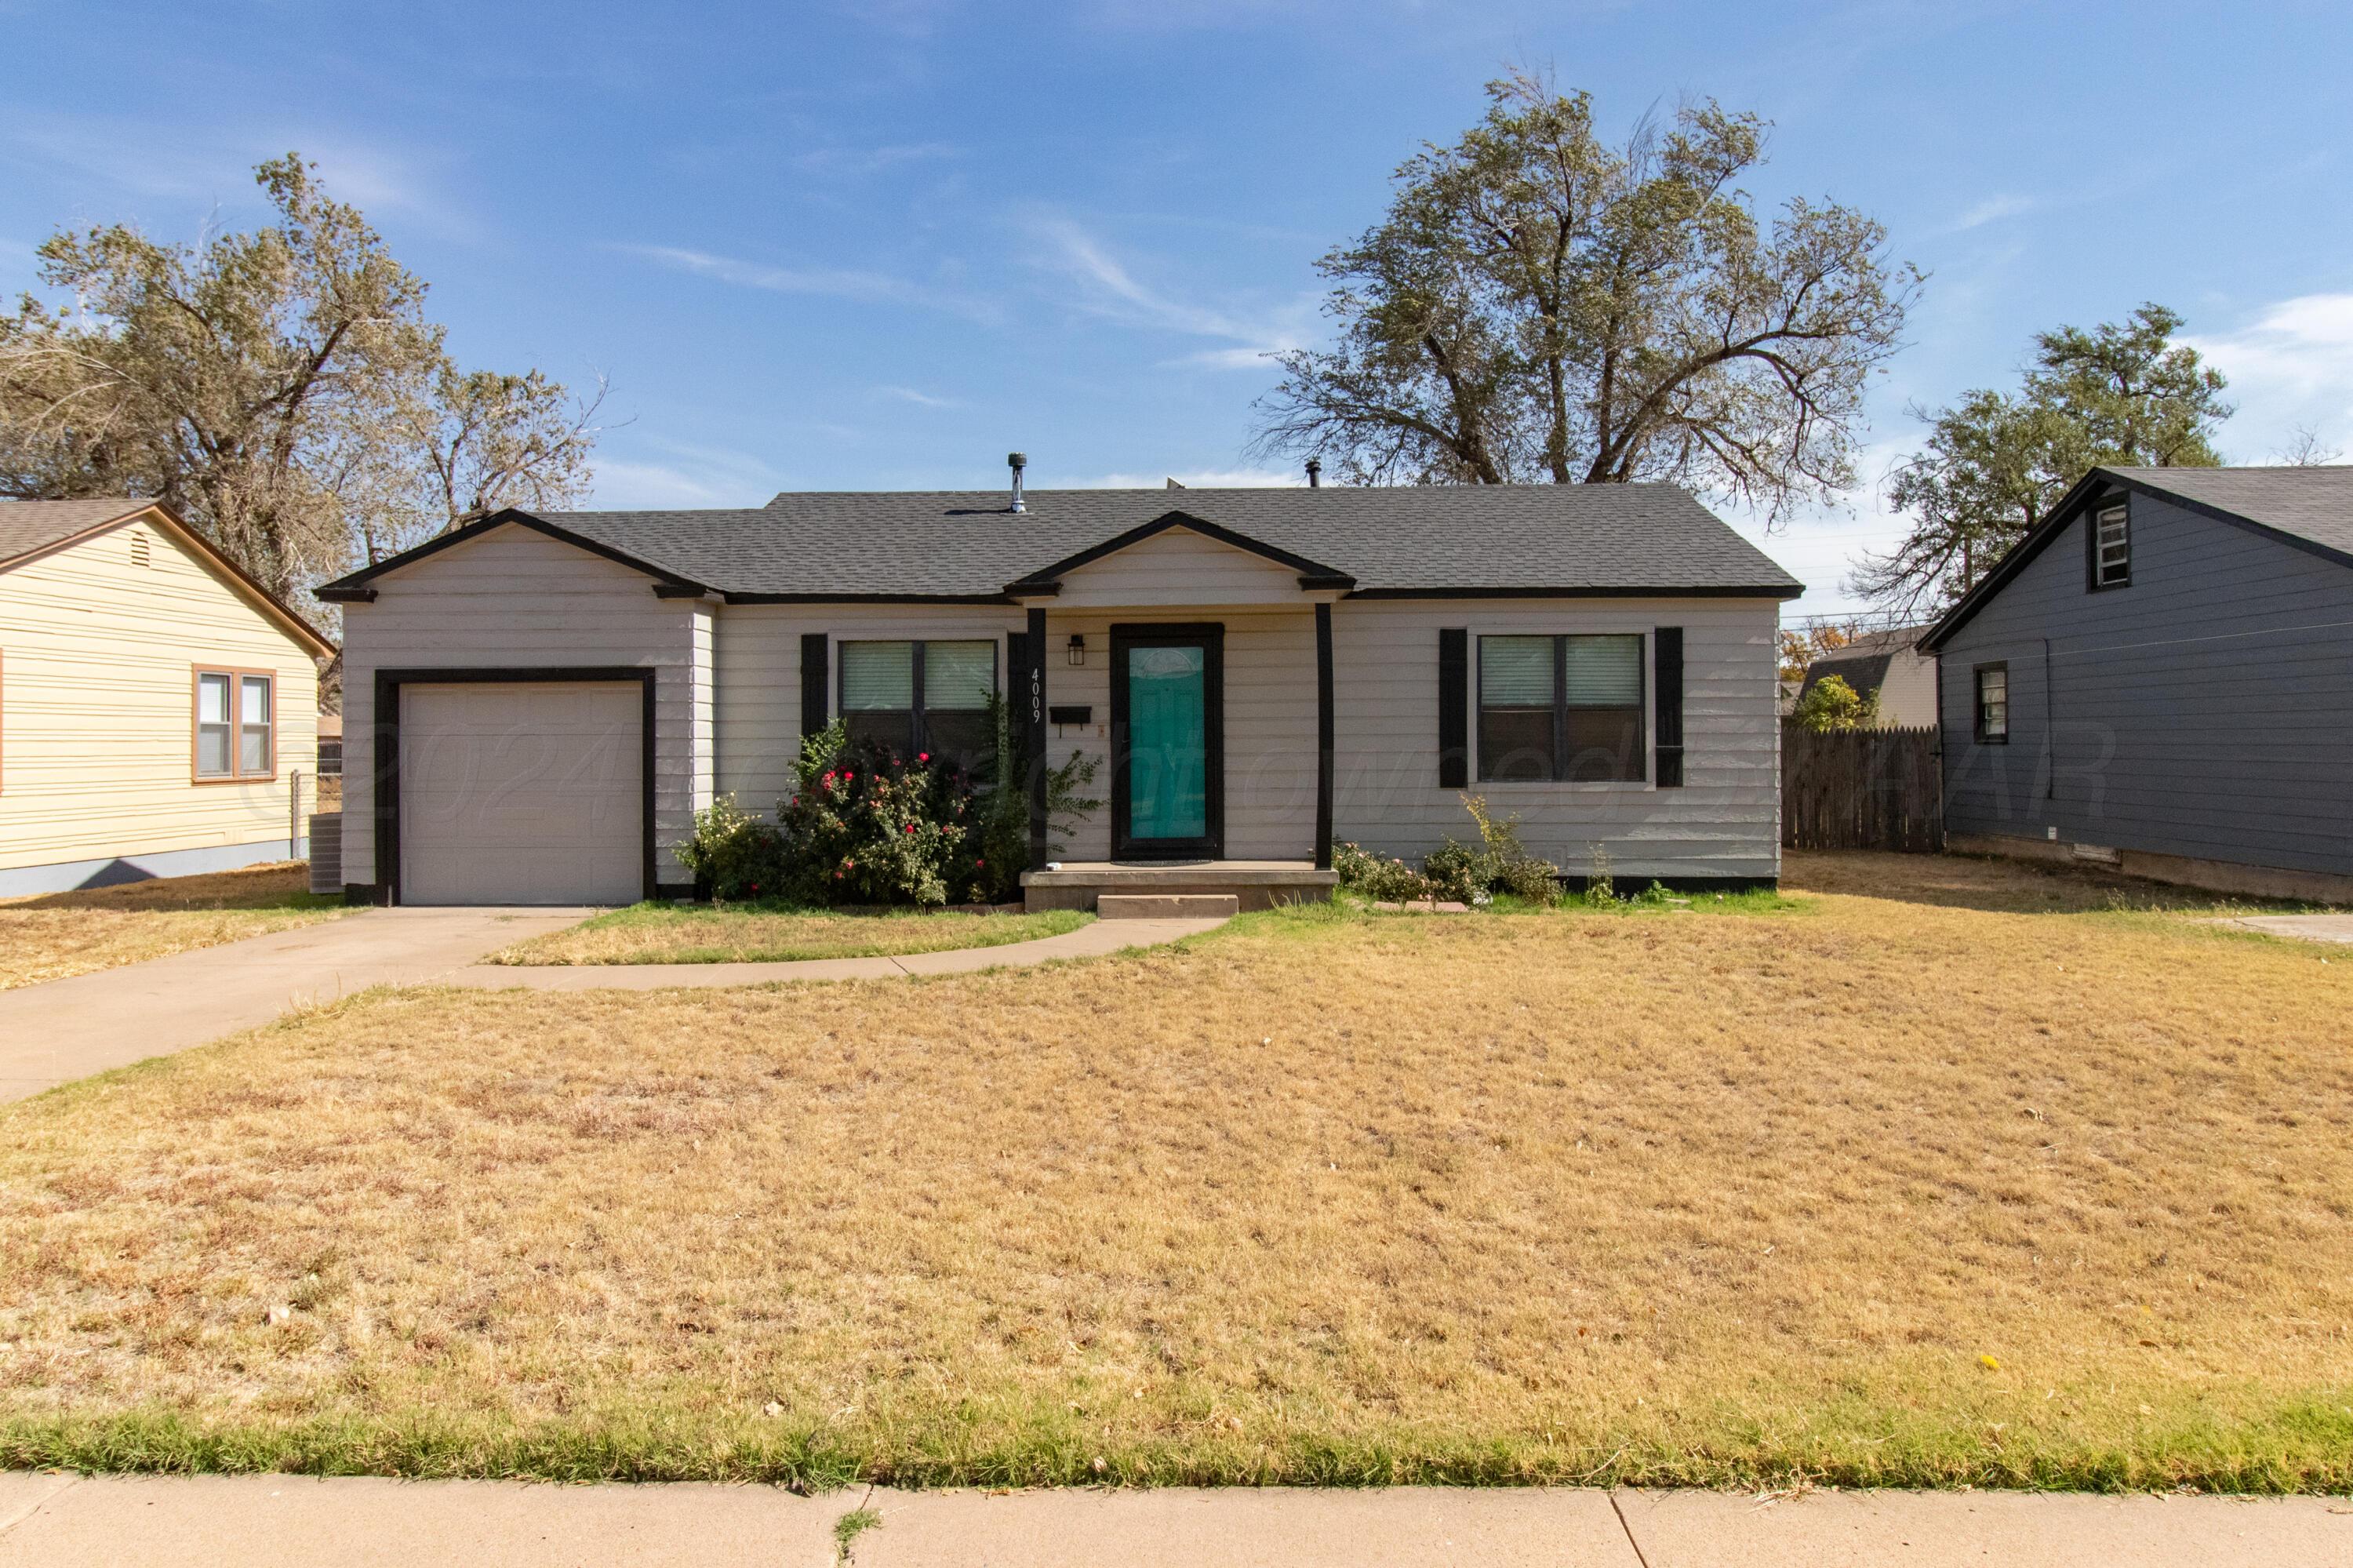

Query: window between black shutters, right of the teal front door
left=1478, top=635, right=1642, bottom=784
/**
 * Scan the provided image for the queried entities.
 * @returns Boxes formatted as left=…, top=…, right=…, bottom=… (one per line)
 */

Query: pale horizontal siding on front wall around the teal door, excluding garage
left=718, top=588, right=1781, bottom=879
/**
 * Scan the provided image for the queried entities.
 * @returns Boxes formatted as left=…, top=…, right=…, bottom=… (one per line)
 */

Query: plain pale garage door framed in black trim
left=400, top=682, right=645, bottom=904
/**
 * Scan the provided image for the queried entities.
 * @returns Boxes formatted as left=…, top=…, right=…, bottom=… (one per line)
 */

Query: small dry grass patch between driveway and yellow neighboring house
left=0, top=860, right=344, bottom=991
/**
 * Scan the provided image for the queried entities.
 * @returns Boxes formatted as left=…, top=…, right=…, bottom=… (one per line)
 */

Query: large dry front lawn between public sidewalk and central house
left=0, top=860, right=2353, bottom=1490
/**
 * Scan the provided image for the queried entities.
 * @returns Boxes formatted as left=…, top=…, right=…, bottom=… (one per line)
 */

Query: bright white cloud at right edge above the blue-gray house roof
left=2184, top=294, right=2353, bottom=461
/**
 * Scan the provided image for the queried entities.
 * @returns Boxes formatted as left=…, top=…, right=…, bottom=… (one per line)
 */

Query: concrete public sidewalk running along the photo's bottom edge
left=0, top=1472, right=2353, bottom=1568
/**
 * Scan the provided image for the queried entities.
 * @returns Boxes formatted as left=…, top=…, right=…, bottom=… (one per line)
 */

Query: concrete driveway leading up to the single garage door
left=0, top=909, right=595, bottom=1102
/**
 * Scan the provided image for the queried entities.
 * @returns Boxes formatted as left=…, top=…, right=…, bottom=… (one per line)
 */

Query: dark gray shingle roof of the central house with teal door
left=322, top=485, right=1805, bottom=602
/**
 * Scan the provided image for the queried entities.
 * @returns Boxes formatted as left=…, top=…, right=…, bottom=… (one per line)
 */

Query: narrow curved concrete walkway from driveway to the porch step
left=442, top=921, right=1226, bottom=991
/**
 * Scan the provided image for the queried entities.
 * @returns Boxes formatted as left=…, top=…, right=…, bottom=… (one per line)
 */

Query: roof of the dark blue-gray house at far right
left=1920, top=464, right=2353, bottom=652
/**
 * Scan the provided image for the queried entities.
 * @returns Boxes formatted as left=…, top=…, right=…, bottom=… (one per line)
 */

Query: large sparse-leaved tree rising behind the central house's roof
left=1254, top=73, right=1920, bottom=515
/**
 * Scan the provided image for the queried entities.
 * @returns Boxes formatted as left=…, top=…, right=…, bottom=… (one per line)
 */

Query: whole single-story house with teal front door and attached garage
left=320, top=473, right=1800, bottom=907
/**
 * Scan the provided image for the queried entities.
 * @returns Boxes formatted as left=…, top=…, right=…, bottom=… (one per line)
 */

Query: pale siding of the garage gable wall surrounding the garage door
left=344, top=527, right=711, bottom=883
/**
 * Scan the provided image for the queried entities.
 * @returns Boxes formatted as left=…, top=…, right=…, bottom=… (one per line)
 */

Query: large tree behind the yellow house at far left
left=0, top=153, right=595, bottom=593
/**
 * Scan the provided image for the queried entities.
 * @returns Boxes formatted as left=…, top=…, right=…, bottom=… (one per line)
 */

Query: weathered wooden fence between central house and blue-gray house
left=1781, top=720, right=1944, bottom=855
